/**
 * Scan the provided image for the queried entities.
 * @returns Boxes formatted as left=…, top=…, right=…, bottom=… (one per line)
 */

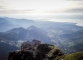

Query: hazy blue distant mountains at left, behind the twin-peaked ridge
left=0, top=17, right=35, bottom=32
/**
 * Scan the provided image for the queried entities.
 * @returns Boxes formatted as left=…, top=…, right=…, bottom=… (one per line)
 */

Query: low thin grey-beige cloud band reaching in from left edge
left=0, top=6, right=34, bottom=14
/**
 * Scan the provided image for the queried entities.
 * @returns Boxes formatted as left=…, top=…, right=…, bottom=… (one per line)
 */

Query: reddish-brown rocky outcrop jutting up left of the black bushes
left=21, top=39, right=41, bottom=51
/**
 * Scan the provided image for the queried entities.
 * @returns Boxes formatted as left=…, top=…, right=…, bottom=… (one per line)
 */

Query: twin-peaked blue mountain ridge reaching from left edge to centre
left=0, top=26, right=50, bottom=43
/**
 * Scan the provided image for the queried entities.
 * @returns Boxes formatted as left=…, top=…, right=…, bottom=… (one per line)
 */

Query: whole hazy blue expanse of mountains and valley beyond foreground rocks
left=0, top=17, right=83, bottom=58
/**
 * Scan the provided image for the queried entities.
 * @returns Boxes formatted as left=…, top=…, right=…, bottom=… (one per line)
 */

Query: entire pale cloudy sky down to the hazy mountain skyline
left=0, top=0, right=83, bottom=25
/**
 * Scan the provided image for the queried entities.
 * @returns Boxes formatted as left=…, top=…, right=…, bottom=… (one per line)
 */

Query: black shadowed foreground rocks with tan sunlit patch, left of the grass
left=3, top=44, right=63, bottom=60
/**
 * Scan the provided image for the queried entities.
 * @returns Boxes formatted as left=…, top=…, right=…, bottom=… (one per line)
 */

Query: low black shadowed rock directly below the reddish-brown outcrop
left=7, top=51, right=34, bottom=60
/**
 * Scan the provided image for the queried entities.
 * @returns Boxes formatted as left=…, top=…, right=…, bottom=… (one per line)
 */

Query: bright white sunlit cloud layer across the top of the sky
left=0, top=0, right=83, bottom=14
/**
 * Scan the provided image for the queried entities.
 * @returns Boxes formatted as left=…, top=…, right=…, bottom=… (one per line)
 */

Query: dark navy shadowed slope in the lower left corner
left=0, top=42, right=19, bottom=60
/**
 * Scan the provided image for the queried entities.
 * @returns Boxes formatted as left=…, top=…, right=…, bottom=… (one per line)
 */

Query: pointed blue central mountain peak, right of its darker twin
left=26, top=26, right=50, bottom=42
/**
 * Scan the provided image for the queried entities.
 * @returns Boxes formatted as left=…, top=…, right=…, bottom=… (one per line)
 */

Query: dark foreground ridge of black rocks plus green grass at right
left=2, top=44, right=83, bottom=60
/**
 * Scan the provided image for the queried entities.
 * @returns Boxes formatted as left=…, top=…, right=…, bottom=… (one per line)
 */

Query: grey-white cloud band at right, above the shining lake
left=45, top=2, right=83, bottom=13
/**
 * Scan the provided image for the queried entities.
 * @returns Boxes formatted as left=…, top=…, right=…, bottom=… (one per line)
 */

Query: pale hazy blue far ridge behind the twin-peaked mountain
left=5, top=17, right=36, bottom=28
